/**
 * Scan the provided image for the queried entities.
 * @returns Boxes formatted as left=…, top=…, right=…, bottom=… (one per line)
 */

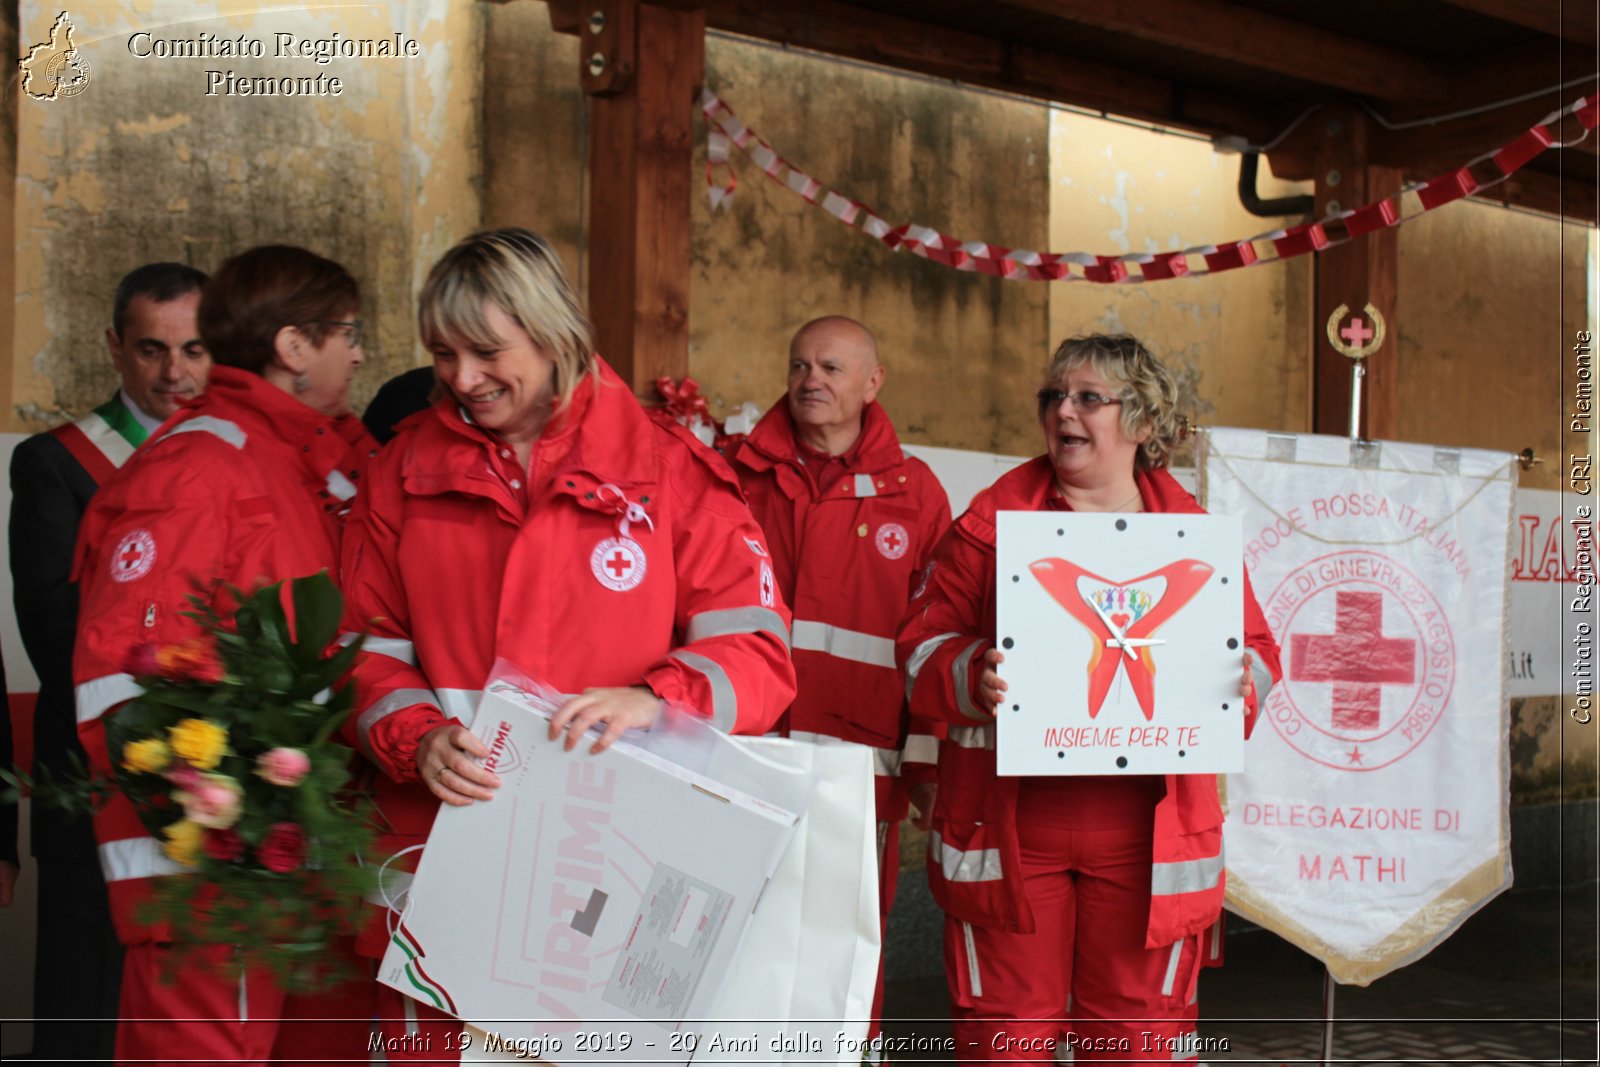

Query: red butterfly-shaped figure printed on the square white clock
left=1027, top=558, right=1214, bottom=721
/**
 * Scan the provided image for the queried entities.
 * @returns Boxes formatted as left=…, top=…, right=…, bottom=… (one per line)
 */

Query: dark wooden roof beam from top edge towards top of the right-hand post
left=1005, top=0, right=1450, bottom=101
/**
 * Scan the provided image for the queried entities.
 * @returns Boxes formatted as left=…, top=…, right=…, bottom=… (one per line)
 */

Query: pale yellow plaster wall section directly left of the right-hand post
left=1050, top=110, right=1315, bottom=460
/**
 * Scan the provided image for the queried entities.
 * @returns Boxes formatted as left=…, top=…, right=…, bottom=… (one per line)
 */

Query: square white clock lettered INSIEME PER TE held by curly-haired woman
left=995, top=512, right=1245, bottom=774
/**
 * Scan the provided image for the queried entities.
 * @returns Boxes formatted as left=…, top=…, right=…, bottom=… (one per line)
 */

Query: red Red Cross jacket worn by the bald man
left=734, top=398, right=950, bottom=799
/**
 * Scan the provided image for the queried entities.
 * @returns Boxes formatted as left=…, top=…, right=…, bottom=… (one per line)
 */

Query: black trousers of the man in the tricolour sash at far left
left=34, top=861, right=122, bottom=1062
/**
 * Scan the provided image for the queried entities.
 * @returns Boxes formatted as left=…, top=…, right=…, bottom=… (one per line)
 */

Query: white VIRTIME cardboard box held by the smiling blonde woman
left=379, top=669, right=816, bottom=1065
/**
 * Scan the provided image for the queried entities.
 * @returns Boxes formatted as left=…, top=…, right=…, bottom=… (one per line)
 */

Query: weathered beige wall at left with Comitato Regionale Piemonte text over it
left=5, top=0, right=482, bottom=430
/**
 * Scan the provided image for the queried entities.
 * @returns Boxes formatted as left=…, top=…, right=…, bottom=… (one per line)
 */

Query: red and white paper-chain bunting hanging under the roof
left=701, top=90, right=1600, bottom=285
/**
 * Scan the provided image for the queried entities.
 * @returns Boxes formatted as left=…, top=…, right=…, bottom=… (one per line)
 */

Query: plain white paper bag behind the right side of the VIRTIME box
left=694, top=737, right=880, bottom=1067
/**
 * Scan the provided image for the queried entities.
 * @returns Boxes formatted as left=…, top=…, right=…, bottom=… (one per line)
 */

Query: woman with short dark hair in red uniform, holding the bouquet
left=74, top=245, right=374, bottom=1062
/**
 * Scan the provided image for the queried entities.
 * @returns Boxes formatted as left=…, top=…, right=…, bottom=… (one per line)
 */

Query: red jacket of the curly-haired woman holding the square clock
left=896, top=456, right=1282, bottom=949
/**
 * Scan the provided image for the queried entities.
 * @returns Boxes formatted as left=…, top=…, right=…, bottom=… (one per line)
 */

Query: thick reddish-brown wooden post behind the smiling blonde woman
left=578, top=0, right=706, bottom=395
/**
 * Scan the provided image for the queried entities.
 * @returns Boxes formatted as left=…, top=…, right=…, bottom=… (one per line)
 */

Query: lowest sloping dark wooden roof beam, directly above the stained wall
left=706, top=0, right=1283, bottom=139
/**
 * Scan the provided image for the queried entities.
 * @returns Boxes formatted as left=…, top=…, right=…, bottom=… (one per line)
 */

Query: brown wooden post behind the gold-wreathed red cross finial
left=1310, top=107, right=1400, bottom=440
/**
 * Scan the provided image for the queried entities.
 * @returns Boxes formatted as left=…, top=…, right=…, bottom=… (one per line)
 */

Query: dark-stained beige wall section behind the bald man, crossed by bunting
left=690, top=37, right=1050, bottom=451
